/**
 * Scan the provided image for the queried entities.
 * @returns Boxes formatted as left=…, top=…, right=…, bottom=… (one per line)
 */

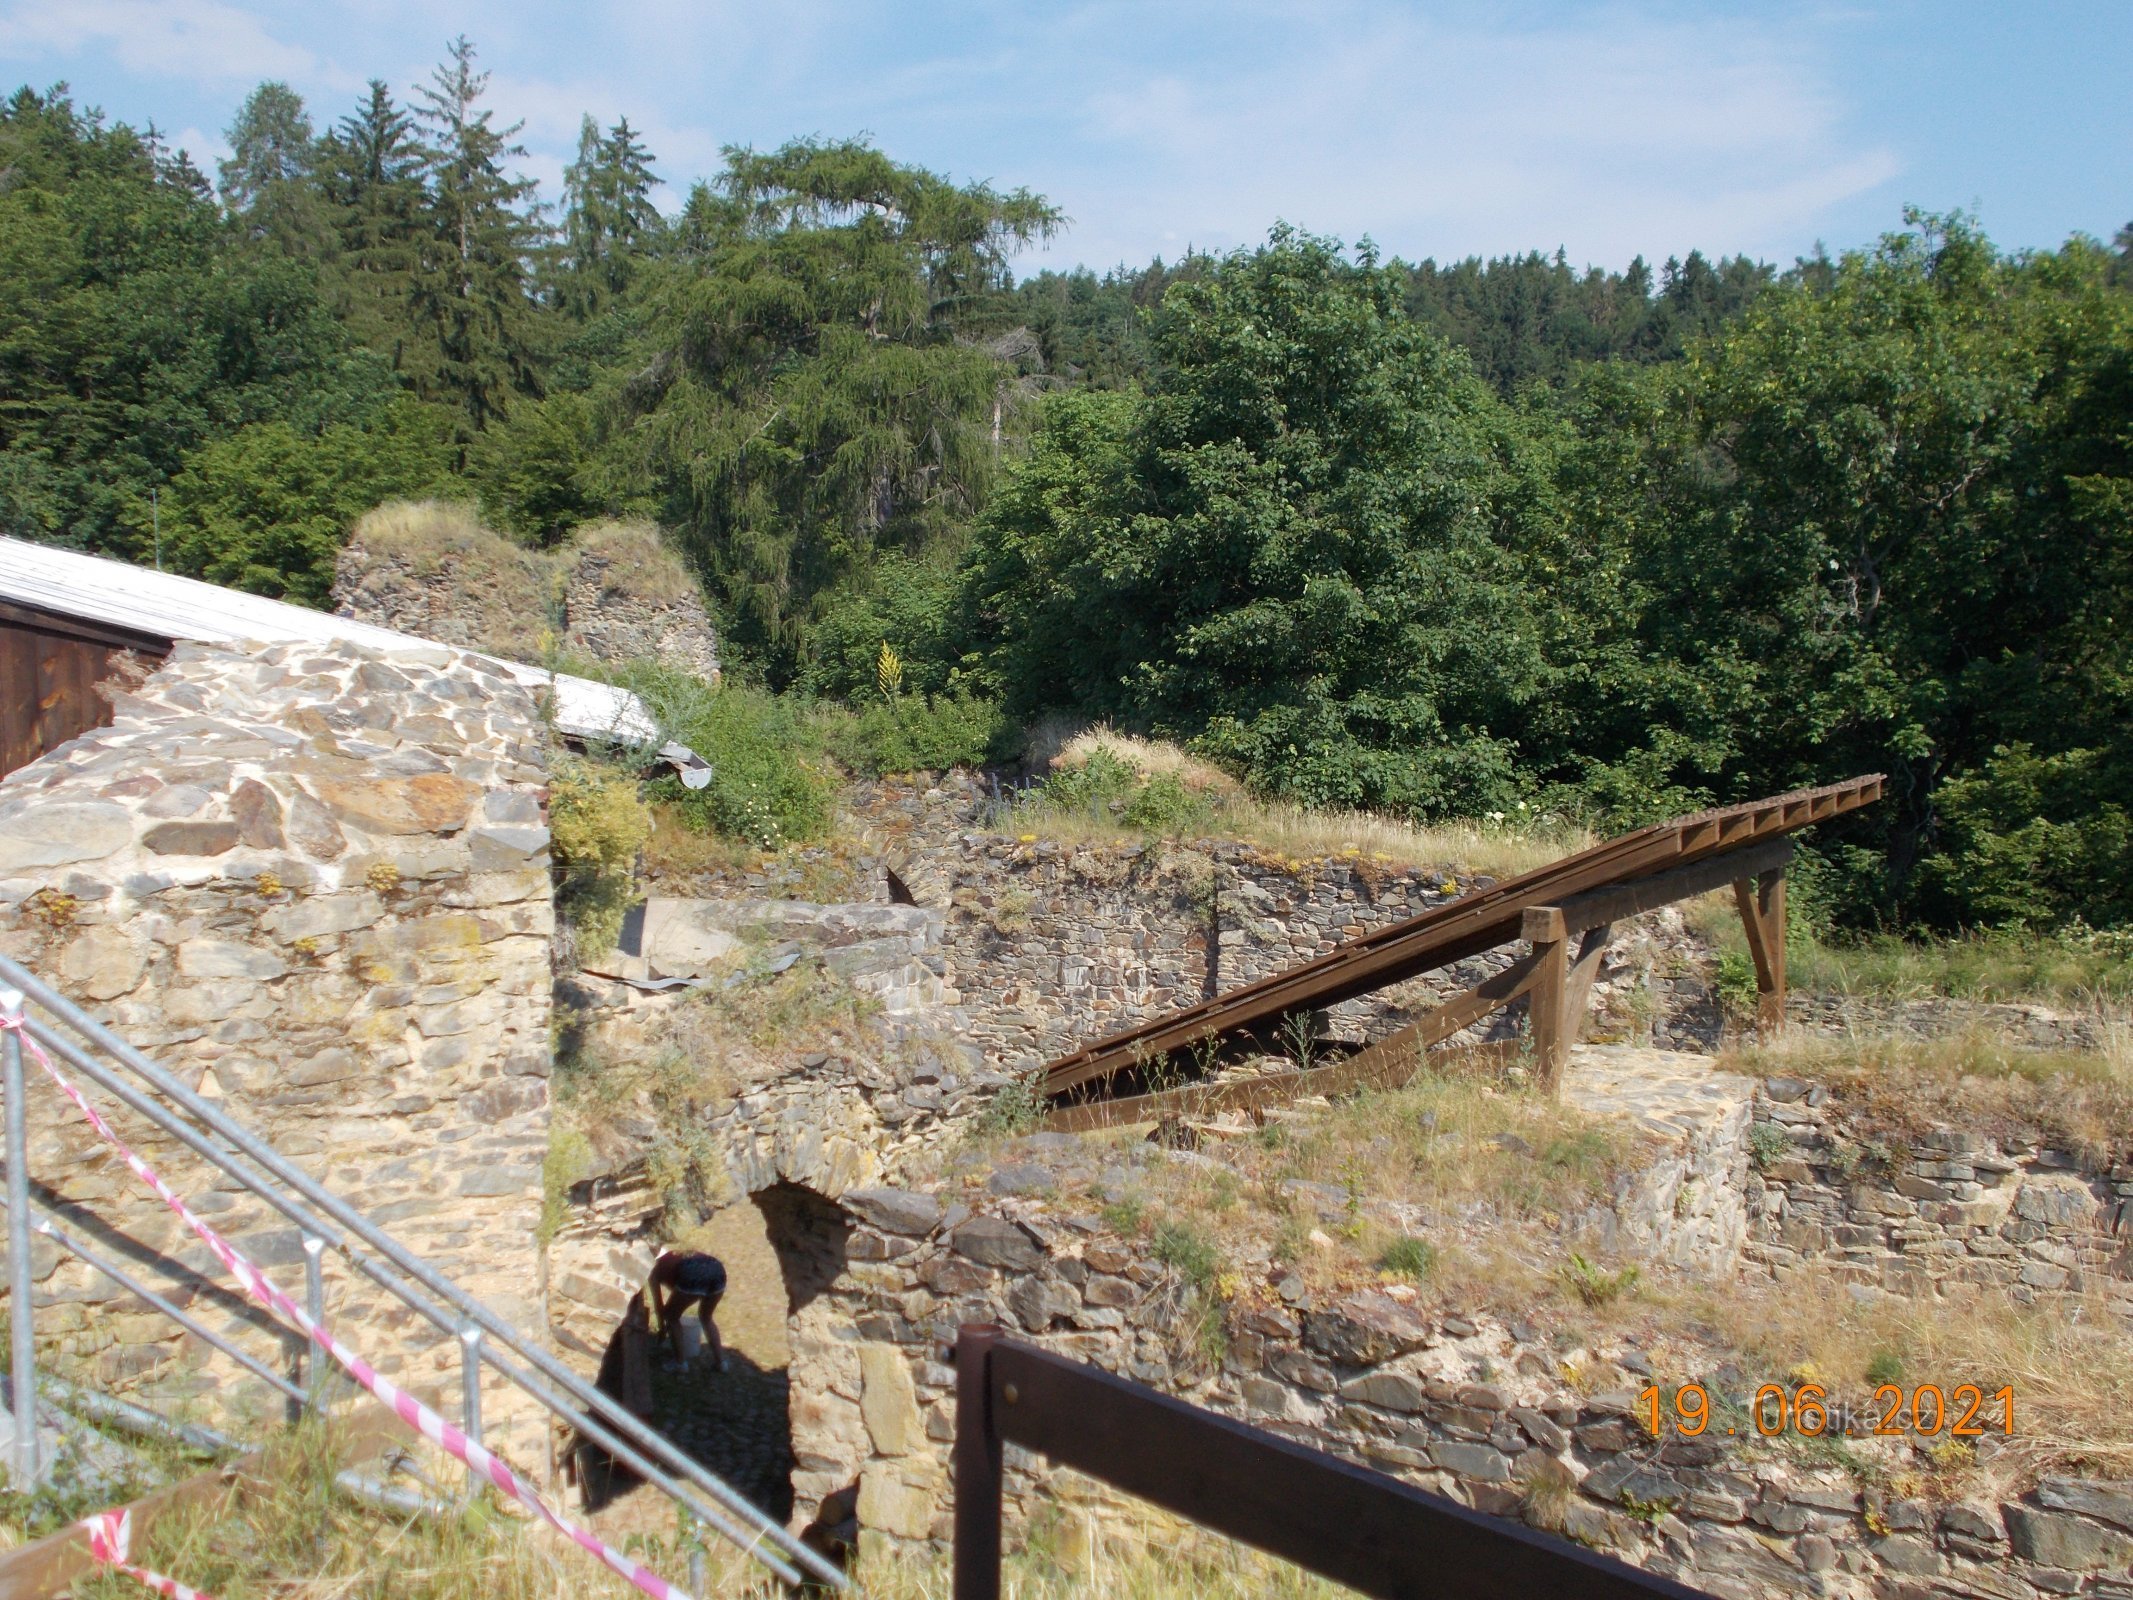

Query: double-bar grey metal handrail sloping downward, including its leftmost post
left=0, top=956, right=849, bottom=1589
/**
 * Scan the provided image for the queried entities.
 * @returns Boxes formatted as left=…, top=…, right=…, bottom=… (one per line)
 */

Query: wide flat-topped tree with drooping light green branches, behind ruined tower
left=629, top=141, right=1058, bottom=681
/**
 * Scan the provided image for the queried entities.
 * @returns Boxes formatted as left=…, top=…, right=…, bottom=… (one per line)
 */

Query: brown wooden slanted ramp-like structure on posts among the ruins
left=1039, top=772, right=1883, bottom=1129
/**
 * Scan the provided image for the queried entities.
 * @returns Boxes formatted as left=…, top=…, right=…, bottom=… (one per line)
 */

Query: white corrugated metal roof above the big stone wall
left=0, top=538, right=659, bottom=745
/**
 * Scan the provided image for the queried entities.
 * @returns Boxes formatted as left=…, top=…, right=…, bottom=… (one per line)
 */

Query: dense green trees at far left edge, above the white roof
left=0, top=90, right=390, bottom=559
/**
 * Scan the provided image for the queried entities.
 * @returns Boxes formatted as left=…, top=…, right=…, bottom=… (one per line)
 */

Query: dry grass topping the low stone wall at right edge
left=1723, top=1015, right=2133, bottom=1165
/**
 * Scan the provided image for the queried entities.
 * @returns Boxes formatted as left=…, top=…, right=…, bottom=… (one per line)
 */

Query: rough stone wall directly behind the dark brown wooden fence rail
left=793, top=1190, right=2133, bottom=1600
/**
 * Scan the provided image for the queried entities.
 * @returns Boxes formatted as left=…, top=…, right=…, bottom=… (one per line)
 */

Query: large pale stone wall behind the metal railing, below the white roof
left=0, top=644, right=552, bottom=1463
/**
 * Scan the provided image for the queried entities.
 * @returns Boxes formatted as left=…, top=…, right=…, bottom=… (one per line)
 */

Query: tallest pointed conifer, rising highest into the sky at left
left=412, top=34, right=542, bottom=437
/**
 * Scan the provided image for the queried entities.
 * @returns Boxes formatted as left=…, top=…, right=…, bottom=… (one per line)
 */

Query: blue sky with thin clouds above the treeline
left=0, top=0, right=2133, bottom=271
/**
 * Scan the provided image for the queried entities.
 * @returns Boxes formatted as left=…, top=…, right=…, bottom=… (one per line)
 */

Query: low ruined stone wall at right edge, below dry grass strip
left=1745, top=1077, right=2133, bottom=1316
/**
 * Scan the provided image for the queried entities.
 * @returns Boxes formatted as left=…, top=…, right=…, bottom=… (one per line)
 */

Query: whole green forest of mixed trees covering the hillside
left=0, top=41, right=2133, bottom=930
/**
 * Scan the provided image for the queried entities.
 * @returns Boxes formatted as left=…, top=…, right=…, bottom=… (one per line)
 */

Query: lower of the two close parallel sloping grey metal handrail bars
left=14, top=1006, right=806, bottom=1585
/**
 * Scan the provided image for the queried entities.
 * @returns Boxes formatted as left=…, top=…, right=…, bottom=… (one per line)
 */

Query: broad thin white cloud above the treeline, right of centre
left=1011, top=6, right=1901, bottom=265
